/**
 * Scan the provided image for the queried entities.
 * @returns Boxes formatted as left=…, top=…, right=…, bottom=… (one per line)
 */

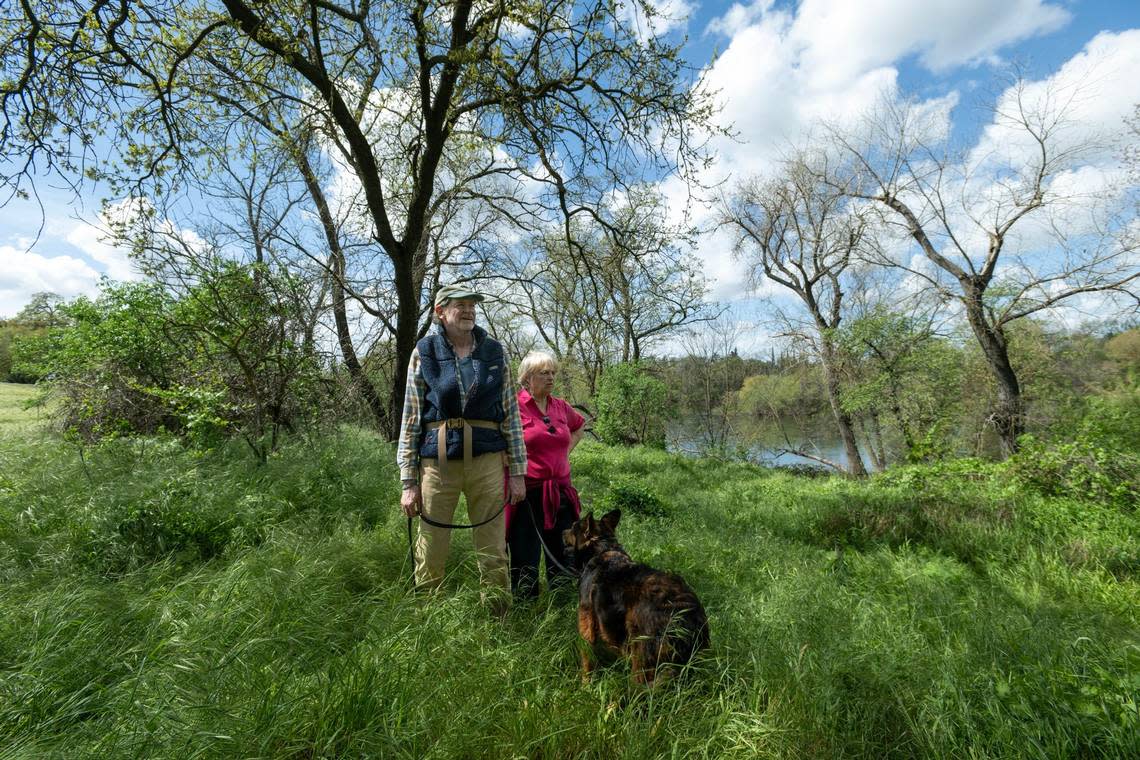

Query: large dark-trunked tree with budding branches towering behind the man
left=0, top=0, right=713, bottom=434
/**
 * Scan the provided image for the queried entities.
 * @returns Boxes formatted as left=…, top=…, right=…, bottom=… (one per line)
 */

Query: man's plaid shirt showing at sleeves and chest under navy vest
left=396, top=336, right=527, bottom=481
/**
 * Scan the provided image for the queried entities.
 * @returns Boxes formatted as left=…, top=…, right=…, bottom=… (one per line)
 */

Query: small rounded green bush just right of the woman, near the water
left=594, top=363, right=671, bottom=448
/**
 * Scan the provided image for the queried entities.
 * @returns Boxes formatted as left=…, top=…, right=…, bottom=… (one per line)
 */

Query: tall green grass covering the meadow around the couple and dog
left=0, top=386, right=1140, bottom=760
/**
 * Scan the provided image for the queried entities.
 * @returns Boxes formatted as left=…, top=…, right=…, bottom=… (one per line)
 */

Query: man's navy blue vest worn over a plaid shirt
left=416, top=326, right=506, bottom=459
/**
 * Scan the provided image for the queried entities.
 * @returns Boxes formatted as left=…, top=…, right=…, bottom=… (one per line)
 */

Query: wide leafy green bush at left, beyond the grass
left=18, top=266, right=321, bottom=460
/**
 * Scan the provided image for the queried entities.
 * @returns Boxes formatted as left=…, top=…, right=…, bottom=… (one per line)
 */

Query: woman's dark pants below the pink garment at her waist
left=506, top=489, right=575, bottom=597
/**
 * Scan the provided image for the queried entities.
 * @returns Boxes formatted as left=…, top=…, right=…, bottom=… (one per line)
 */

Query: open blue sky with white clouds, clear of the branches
left=0, top=0, right=1140, bottom=328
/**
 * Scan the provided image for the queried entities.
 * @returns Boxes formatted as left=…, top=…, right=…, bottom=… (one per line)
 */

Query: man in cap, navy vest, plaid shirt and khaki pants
left=396, top=285, right=527, bottom=612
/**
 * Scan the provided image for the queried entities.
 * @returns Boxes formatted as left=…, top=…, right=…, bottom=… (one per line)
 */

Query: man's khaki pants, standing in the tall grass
left=416, top=452, right=511, bottom=593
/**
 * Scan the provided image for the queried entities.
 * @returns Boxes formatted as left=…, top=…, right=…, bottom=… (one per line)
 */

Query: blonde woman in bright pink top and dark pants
left=506, top=351, right=586, bottom=597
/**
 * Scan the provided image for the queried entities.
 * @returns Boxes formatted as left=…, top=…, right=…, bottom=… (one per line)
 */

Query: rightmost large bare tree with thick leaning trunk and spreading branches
left=827, top=79, right=1140, bottom=455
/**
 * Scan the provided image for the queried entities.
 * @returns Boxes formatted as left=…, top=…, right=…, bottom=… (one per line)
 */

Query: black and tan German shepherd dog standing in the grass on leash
left=562, top=509, right=709, bottom=686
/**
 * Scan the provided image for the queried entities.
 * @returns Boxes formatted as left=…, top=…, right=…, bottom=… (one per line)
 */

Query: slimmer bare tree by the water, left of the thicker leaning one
left=720, top=153, right=868, bottom=475
